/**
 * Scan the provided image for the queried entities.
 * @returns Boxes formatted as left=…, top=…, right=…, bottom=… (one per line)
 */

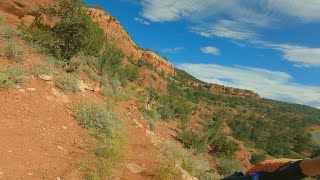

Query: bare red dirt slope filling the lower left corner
left=0, top=80, right=93, bottom=179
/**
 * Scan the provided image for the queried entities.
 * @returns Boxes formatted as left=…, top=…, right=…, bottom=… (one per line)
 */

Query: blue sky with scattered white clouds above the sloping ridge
left=87, top=0, right=320, bottom=108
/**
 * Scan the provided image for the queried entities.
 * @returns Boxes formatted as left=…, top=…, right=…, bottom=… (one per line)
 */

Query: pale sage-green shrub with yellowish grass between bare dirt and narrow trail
left=73, top=104, right=125, bottom=179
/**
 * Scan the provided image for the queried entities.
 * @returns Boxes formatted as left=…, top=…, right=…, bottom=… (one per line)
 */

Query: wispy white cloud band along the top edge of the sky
left=141, top=0, right=320, bottom=23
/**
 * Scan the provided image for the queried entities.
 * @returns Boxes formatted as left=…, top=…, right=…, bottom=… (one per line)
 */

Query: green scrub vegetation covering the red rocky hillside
left=0, top=0, right=320, bottom=179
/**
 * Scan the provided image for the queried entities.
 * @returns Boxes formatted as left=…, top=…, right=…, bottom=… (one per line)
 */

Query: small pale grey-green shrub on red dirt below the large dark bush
left=55, top=73, right=79, bottom=92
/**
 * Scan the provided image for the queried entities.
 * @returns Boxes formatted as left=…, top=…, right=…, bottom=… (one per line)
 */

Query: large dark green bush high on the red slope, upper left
left=20, top=0, right=106, bottom=60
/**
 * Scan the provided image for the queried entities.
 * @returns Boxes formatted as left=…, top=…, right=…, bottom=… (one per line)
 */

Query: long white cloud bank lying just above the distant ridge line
left=178, top=64, right=320, bottom=107
